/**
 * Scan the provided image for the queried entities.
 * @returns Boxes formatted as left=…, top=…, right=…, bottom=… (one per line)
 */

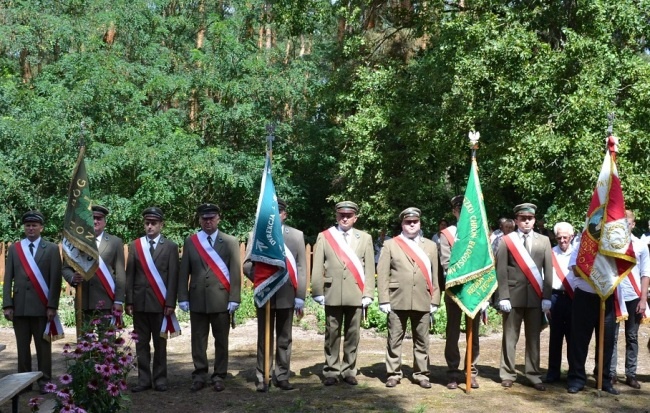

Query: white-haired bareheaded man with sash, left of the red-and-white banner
left=544, top=222, right=573, bottom=383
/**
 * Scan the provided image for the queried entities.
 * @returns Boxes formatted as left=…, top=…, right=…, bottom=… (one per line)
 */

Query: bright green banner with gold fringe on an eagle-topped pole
left=445, top=157, right=497, bottom=318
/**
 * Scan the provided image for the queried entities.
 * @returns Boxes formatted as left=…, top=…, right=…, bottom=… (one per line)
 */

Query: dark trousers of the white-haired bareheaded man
left=546, top=290, right=573, bottom=382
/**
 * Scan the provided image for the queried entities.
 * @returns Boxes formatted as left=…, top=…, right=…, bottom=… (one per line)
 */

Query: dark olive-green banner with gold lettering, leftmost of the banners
left=61, top=146, right=99, bottom=280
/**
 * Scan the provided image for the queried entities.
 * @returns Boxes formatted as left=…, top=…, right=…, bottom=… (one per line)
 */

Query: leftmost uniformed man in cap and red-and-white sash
left=2, top=211, right=61, bottom=393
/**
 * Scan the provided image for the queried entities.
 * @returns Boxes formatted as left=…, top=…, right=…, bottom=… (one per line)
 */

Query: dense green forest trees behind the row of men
left=0, top=0, right=650, bottom=242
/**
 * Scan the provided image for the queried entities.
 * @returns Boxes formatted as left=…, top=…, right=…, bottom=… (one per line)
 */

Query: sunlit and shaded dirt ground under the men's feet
left=0, top=316, right=650, bottom=413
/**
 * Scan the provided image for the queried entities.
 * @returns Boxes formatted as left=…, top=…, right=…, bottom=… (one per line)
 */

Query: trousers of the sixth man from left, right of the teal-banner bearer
left=323, top=305, right=361, bottom=378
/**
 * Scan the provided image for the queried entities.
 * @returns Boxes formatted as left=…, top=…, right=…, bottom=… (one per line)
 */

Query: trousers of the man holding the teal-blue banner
left=255, top=306, right=293, bottom=383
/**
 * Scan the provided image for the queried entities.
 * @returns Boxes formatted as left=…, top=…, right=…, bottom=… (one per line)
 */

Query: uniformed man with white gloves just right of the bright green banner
left=497, top=203, right=553, bottom=391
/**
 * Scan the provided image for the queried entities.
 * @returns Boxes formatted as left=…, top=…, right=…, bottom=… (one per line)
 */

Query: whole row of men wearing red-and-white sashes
left=3, top=196, right=650, bottom=394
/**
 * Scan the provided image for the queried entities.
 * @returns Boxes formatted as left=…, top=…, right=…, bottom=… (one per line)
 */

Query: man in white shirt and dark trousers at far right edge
left=609, top=210, right=650, bottom=389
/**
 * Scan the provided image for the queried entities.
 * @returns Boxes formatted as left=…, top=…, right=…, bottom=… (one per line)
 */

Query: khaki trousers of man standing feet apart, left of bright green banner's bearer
left=386, top=310, right=430, bottom=382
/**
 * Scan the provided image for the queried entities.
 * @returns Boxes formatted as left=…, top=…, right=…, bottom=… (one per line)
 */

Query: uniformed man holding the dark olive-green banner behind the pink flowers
left=63, top=205, right=126, bottom=318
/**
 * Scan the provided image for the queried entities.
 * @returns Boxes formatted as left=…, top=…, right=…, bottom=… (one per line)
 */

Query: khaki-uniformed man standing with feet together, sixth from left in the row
left=311, top=201, right=375, bottom=386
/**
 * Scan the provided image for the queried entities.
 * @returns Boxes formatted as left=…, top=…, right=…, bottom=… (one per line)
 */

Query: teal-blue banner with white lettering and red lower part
left=250, top=153, right=289, bottom=307
